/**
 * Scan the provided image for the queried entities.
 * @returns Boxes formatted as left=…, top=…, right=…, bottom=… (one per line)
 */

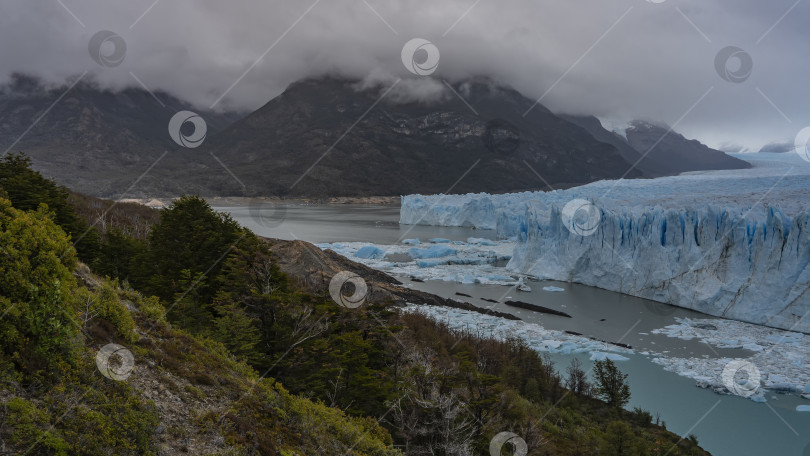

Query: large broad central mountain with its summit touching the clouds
left=189, top=78, right=640, bottom=196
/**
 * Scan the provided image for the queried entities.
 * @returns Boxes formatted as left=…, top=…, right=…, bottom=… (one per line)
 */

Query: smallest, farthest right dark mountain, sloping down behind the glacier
left=562, top=115, right=750, bottom=177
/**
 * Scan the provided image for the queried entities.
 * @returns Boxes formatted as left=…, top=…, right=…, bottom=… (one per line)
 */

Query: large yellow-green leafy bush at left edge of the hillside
left=0, top=199, right=78, bottom=372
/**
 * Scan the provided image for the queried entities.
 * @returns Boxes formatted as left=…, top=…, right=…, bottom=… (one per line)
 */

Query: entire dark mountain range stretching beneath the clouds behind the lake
left=0, top=76, right=747, bottom=198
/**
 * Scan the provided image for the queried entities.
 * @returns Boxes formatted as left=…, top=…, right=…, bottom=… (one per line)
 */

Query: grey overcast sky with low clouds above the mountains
left=0, top=0, right=810, bottom=149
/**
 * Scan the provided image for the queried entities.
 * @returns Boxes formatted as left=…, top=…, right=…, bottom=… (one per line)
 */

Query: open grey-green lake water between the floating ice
left=215, top=204, right=810, bottom=456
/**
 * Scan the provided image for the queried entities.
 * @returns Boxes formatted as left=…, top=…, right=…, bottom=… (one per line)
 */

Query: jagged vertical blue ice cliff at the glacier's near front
left=507, top=206, right=810, bottom=332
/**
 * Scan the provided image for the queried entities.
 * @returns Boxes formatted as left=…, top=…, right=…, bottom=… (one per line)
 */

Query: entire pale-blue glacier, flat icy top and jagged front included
left=400, top=153, right=810, bottom=332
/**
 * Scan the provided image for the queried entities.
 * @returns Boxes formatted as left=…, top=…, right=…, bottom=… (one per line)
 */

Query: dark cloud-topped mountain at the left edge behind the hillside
left=0, top=74, right=237, bottom=195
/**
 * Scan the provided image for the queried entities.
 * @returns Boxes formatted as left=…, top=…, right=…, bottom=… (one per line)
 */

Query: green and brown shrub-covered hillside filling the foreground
left=0, top=158, right=706, bottom=456
